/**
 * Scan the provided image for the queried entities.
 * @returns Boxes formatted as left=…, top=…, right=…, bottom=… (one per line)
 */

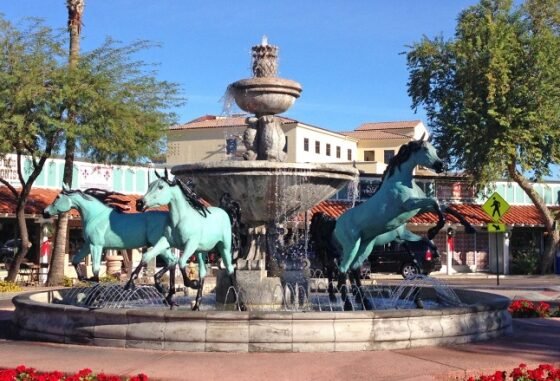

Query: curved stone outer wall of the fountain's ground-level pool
left=13, top=289, right=511, bottom=352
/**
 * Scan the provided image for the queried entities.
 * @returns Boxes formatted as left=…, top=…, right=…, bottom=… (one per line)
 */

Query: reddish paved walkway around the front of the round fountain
left=0, top=278, right=560, bottom=381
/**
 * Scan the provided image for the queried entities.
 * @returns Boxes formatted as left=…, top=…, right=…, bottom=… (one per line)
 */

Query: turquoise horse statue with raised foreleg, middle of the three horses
left=129, top=171, right=238, bottom=310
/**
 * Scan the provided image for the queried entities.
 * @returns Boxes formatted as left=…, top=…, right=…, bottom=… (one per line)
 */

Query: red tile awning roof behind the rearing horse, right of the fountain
left=311, top=201, right=544, bottom=226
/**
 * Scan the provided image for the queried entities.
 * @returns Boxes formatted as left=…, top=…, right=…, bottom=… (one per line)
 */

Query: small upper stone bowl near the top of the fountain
left=228, top=77, right=301, bottom=115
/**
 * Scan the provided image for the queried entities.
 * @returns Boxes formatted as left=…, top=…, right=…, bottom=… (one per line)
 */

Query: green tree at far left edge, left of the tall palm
left=0, top=16, right=67, bottom=281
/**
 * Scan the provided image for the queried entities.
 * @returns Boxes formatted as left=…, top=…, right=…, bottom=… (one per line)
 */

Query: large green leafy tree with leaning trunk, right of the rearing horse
left=407, top=0, right=560, bottom=273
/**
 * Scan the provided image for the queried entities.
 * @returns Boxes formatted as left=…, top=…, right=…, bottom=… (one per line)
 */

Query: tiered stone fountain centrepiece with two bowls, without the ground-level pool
left=172, top=37, right=359, bottom=309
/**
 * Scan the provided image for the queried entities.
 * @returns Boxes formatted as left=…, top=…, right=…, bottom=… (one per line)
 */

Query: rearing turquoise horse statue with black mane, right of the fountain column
left=310, top=135, right=472, bottom=310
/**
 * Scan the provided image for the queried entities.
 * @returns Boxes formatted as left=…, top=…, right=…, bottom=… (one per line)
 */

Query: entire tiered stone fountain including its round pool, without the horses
left=9, top=39, right=511, bottom=352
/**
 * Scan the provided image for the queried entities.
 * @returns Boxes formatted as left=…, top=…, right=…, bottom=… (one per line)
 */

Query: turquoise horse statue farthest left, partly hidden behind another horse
left=43, top=184, right=177, bottom=302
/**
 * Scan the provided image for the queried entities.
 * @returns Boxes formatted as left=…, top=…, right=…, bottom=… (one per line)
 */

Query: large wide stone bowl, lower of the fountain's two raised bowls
left=171, top=161, right=359, bottom=225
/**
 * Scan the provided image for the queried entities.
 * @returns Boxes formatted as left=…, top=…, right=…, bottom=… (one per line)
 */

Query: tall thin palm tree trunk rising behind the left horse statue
left=47, top=0, right=85, bottom=286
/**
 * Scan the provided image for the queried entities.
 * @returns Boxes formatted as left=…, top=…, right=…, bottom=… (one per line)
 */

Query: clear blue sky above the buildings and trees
left=0, top=0, right=477, bottom=131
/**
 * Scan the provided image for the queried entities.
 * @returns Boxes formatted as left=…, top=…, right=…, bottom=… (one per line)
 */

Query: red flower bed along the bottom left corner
left=0, top=365, right=148, bottom=381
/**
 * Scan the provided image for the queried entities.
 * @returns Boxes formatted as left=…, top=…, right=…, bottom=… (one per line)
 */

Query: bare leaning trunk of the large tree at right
left=508, top=161, right=560, bottom=274
